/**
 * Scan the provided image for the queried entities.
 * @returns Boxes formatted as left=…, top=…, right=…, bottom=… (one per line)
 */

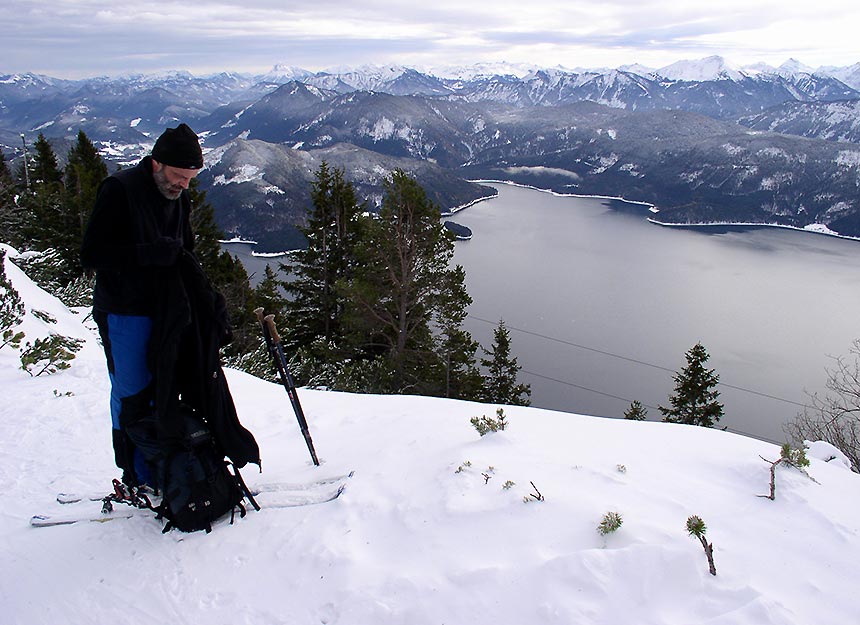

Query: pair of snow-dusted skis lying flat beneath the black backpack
left=30, top=474, right=351, bottom=527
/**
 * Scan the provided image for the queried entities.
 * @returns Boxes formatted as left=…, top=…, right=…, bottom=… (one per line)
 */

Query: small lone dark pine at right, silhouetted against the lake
left=659, top=343, right=723, bottom=427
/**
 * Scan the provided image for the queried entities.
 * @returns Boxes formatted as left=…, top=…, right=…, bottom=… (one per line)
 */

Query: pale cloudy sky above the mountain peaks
left=6, top=0, right=860, bottom=78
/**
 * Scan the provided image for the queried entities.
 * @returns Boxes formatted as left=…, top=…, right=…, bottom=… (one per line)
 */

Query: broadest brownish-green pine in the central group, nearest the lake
left=346, top=170, right=478, bottom=395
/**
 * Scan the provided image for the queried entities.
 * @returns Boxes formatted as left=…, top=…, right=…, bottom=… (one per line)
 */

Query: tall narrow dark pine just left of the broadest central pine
left=282, top=161, right=364, bottom=356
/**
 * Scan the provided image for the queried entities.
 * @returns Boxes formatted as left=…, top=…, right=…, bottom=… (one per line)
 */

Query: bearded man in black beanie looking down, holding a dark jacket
left=81, top=124, right=259, bottom=486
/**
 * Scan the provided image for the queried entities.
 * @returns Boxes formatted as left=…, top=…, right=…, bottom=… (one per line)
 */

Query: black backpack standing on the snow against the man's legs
left=126, top=406, right=260, bottom=533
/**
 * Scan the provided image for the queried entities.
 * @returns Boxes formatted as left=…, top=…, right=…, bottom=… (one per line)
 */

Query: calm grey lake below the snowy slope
left=229, top=184, right=860, bottom=443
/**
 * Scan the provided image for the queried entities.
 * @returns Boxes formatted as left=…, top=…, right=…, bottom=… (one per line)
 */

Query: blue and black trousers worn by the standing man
left=93, top=313, right=152, bottom=484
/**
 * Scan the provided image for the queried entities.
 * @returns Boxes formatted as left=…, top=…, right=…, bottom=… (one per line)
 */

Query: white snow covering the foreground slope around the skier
left=0, top=245, right=860, bottom=625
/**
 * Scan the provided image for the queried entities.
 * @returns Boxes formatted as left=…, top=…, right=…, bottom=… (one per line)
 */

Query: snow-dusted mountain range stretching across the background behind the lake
left=0, top=57, right=860, bottom=249
